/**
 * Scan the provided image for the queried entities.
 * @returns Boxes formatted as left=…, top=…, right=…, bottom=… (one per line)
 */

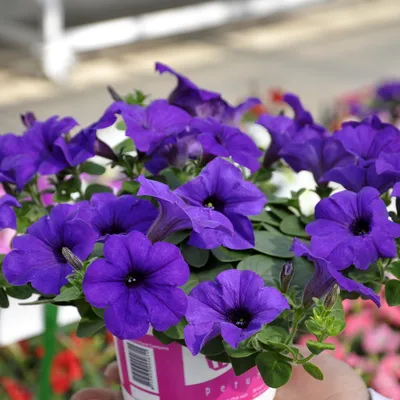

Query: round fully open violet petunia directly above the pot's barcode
left=82, top=231, right=189, bottom=339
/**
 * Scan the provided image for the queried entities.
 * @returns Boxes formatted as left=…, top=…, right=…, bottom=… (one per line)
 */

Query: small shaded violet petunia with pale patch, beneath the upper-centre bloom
left=144, top=132, right=202, bottom=174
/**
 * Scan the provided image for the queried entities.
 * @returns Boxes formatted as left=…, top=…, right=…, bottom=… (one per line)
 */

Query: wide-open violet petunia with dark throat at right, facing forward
left=306, top=187, right=400, bottom=270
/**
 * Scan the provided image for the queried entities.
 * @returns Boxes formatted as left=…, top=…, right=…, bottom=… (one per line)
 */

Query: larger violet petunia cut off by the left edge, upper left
left=0, top=133, right=38, bottom=190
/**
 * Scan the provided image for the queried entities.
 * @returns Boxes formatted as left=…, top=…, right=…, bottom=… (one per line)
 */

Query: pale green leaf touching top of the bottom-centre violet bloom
left=237, top=254, right=284, bottom=286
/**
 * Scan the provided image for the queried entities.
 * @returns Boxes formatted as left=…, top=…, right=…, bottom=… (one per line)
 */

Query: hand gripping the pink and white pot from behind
left=71, top=349, right=369, bottom=400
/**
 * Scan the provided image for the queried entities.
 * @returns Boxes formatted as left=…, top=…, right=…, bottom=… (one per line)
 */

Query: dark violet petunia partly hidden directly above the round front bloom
left=90, top=193, right=158, bottom=242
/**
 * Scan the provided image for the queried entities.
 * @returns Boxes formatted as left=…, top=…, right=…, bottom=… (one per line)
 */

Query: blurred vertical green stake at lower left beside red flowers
left=38, top=304, right=57, bottom=400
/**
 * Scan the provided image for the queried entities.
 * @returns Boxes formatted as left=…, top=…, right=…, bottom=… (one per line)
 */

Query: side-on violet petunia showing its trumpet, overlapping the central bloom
left=137, top=176, right=233, bottom=248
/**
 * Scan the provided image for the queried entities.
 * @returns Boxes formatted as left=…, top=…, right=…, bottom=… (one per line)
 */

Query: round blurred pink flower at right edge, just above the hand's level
left=362, top=324, right=400, bottom=354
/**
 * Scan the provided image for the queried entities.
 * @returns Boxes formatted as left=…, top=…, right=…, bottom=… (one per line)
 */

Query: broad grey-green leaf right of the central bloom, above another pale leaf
left=254, top=231, right=293, bottom=258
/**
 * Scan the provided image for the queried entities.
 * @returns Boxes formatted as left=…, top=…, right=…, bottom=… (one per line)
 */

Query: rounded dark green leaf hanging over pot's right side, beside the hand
left=256, top=352, right=292, bottom=389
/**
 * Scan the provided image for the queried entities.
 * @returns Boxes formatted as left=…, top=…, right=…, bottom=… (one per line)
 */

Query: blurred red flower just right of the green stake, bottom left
left=50, top=350, right=83, bottom=394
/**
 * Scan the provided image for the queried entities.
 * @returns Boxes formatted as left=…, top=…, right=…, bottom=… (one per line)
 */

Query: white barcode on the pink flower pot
left=125, top=342, right=158, bottom=393
